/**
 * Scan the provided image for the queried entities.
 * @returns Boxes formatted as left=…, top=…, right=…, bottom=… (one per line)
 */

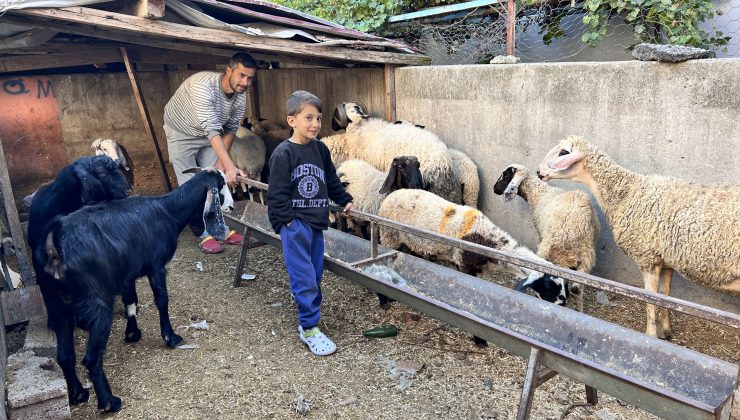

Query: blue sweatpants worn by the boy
left=280, top=218, right=324, bottom=329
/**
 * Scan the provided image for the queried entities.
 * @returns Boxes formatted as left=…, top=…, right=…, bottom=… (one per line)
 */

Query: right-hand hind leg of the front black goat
left=82, top=305, right=121, bottom=413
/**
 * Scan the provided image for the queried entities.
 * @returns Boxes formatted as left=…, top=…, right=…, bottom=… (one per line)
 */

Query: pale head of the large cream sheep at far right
left=537, top=136, right=588, bottom=181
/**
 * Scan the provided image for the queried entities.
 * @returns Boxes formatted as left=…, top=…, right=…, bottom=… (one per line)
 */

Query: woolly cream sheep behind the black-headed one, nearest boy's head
left=322, top=103, right=454, bottom=204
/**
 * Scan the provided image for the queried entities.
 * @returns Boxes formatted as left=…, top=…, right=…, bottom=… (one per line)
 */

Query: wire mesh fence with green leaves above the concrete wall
left=383, top=0, right=740, bottom=64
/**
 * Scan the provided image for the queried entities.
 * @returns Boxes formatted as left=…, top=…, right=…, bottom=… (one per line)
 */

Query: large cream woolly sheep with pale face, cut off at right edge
left=538, top=136, right=740, bottom=338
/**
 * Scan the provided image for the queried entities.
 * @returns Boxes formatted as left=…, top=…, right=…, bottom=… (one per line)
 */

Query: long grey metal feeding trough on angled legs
left=227, top=194, right=738, bottom=419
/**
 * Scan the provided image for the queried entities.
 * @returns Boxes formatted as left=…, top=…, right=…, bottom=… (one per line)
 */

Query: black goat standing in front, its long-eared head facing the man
left=34, top=170, right=233, bottom=412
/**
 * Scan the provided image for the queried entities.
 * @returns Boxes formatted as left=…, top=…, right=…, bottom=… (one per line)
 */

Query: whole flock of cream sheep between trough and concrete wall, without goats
left=232, top=102, right=740, bottom=338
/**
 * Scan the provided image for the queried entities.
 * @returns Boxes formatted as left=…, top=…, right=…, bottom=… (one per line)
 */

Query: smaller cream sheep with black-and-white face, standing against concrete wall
left=493, top=164, right=601, bottom=311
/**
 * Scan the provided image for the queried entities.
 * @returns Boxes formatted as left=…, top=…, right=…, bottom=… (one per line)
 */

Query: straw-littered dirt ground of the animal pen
left=4, top=162, right=740, bottom=420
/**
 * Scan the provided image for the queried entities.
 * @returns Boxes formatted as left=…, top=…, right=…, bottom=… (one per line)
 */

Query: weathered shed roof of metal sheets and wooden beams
left=0, top=0, right=430, bottom=72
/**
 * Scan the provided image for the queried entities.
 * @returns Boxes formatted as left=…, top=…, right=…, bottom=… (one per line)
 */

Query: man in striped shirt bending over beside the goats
left=164, top=52, right=257, bottom=254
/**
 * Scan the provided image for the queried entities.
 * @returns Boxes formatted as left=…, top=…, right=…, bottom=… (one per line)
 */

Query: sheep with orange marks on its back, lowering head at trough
left=378, top=189, right=568, bottom=305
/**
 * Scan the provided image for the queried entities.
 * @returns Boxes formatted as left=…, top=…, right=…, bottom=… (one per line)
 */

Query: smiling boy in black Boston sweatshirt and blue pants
left=267, top=90, right=352, bottom=356
